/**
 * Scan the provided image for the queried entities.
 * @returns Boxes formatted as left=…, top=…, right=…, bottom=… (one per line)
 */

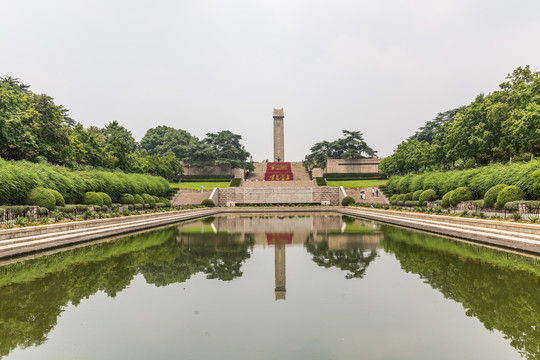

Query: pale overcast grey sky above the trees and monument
left=0, top=0, right=540, bottom=161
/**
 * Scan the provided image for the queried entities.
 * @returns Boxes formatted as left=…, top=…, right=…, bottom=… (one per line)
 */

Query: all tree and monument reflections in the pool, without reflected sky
left=0, top=215, right=540, bottom=360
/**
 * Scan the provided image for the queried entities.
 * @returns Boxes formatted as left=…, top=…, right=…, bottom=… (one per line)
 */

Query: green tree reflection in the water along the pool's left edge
left=0, top=228, right=251, bottom=357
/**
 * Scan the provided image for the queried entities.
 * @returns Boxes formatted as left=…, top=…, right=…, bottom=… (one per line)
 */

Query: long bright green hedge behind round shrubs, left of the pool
left=0, top=159, right=170, bottom=204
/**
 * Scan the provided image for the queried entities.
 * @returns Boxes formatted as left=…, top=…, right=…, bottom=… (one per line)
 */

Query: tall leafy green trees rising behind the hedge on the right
left=379, top=65, right=540, bottom=174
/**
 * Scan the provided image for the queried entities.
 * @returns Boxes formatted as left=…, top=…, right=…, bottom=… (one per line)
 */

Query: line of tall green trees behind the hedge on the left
left=0, top=77, right=253, bottom=180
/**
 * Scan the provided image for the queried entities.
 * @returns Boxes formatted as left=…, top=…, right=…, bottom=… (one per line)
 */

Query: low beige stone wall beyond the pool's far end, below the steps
left=218, top=186, right=339, bottom=205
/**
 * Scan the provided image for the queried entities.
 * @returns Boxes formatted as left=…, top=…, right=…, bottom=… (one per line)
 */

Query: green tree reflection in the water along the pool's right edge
left=383, top=228, right=540, bottom=360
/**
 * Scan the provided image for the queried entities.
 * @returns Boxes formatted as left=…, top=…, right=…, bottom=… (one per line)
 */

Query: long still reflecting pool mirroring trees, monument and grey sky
left=0, top=213, right=540, bottom=360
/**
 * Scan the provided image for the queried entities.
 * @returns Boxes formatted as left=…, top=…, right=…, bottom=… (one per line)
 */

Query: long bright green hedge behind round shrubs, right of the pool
left=387, top=159, right=540, bottom=200
